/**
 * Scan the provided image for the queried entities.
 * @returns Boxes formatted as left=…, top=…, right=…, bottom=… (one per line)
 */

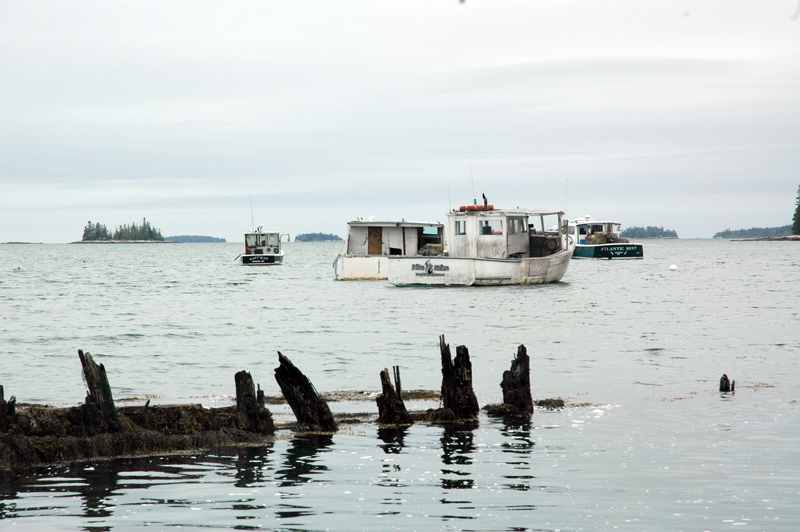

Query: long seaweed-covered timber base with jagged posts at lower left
left=0, top=351, right=274, bottom=470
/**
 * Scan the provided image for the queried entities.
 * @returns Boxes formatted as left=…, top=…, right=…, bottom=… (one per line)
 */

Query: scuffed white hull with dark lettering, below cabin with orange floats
left=389, top=249, right=572, bottom=286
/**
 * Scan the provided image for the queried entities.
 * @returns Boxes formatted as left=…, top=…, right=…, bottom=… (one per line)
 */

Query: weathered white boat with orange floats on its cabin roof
left=389, top=199, right=574, bottom=286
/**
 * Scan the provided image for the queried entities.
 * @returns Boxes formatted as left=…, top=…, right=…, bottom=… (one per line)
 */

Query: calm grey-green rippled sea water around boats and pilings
left=0, top=240, right=800, bottom=531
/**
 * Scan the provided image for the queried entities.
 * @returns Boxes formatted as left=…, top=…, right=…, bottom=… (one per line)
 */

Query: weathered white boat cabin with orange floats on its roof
left=447, top=205, right=566, bottom=259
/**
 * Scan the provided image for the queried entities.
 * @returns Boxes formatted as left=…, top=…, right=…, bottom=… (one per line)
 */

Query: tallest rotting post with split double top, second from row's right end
left=439, top=335, right=480, bottom=420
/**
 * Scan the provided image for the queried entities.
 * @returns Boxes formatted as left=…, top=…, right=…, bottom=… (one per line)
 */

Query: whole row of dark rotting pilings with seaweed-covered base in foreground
left=0, top=336, right=533, bottom=469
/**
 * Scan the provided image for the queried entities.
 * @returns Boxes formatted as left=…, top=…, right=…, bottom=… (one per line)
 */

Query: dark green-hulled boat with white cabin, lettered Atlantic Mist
left=569, top=216, right=644, bottom=260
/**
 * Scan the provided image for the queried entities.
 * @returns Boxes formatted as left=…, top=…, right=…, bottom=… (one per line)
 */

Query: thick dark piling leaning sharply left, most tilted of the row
left=275, top=351, right=339, bottom=432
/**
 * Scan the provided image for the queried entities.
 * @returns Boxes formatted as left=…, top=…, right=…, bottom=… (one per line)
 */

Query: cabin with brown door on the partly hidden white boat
left=345, top=220, right=444, bottom=256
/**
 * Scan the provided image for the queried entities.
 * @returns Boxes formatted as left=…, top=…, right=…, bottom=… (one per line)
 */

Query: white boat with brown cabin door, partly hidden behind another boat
left=333, top=219, right=444, bottom=281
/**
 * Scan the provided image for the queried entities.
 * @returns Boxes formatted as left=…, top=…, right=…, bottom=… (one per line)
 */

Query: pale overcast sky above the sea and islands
left=0, top=0, right=800, bottom=243
